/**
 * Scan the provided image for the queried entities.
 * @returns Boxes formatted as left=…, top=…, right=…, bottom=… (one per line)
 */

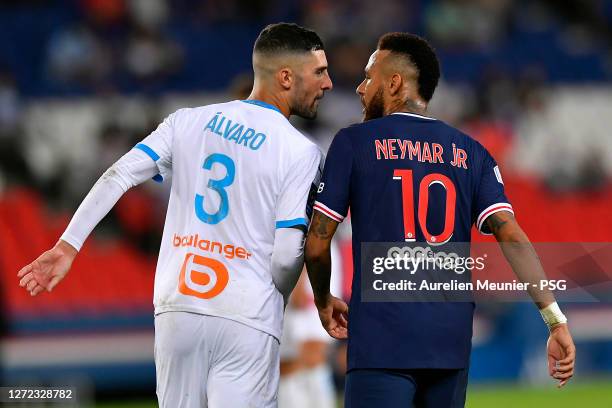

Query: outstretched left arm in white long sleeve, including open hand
left=17, top=149, right=158, bottom=296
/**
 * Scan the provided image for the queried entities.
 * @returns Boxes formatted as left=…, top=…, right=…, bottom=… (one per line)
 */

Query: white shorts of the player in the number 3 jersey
left=155, top=312, right=279, bottom=408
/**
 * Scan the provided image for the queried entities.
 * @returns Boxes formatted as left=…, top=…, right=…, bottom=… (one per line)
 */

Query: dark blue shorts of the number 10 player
left=345, top=368, right=468, bottom=408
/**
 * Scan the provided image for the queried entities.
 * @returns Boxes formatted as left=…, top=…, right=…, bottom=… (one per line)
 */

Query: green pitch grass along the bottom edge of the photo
left=96, top=378, right=612, bottom=408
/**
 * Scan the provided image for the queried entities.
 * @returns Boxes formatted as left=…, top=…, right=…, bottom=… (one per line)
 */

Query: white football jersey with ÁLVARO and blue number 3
left=136, top=101, right=322, bottom=339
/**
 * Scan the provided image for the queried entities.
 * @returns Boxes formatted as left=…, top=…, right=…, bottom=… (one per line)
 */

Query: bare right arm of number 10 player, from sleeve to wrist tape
left=487, top=212, right=555, bottom=309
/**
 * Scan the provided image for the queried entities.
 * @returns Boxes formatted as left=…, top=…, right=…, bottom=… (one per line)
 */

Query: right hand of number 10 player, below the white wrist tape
left=546, top=323, right=576, bottom=388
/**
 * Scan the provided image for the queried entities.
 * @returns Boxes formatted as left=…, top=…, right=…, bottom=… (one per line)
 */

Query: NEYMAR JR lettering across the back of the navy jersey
left=374, top=139, right=468, bottom=169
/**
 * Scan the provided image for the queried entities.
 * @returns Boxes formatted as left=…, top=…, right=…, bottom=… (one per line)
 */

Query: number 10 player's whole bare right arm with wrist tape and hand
left=486, top=211, right=576, bottom=387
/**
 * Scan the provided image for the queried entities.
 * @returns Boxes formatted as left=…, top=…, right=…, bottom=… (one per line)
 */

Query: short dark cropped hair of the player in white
left=253, top=23, right=324, bottom=54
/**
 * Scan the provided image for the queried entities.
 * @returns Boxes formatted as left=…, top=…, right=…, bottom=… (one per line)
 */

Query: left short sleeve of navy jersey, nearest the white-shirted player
left=314, top=130, right=353, bottom=222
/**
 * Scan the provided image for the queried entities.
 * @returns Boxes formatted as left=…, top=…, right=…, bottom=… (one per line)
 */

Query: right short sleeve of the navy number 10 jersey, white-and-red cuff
left=474, top=148, right=514, bottom=235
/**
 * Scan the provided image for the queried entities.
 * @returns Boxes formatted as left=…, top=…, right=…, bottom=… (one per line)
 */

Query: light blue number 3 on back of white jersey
left=195, top=153, right=236, bottom=224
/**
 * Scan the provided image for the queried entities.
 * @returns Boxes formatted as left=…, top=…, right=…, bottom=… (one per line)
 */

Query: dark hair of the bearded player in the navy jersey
left=378, top=33, right=440, bottom=102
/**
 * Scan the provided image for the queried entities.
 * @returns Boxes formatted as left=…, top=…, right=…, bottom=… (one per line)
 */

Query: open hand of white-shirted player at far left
left=17, top=240, right=77, bottom=296
